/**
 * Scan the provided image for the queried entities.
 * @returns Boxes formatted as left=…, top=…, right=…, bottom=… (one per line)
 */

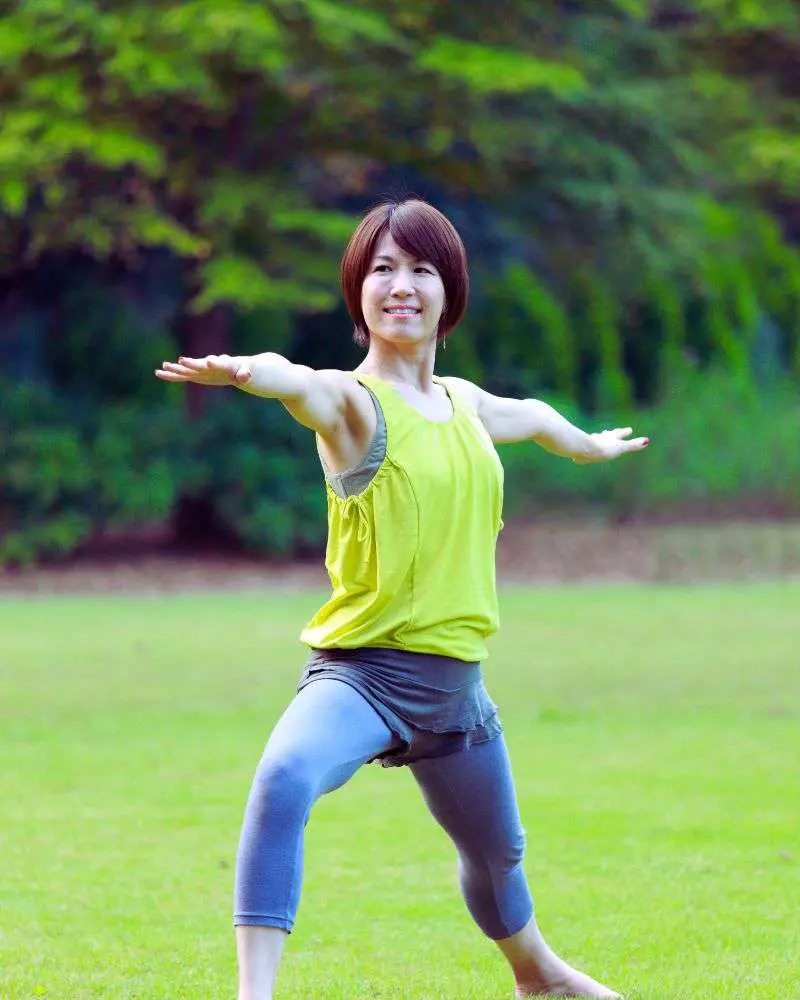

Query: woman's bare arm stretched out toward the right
left=444, top=378, right=650, bottom=464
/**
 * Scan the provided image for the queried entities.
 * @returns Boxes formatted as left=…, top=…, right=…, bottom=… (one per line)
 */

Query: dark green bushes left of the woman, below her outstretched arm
left=0, top=376, right=326, bottom=565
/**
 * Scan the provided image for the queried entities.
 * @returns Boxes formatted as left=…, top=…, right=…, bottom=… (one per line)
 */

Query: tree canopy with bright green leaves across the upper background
left=0, top=0, right=800, bottom=564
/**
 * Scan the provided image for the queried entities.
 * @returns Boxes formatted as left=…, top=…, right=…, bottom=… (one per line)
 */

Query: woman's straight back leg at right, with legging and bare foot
left=411, top=736, right=619, bottom=998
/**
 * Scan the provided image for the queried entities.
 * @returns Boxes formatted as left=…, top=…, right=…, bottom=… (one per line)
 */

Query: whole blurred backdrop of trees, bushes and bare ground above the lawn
left=0, top=0, right=800, bottom=585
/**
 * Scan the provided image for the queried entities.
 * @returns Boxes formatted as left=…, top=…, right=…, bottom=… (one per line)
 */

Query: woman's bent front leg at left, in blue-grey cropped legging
left=234, top=679, right=396, bottom=1000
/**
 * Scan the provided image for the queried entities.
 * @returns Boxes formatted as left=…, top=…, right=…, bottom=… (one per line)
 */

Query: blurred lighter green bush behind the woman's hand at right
left=500, top=363, right=800, bottom=519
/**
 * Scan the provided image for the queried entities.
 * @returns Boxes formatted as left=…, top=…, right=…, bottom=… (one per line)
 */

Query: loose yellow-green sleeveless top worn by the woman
left=301, top=373, right=503, bottom=662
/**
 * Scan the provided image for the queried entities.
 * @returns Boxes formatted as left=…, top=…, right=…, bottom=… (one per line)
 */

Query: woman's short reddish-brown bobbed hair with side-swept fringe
left=341, top=199, right=469, bottom=347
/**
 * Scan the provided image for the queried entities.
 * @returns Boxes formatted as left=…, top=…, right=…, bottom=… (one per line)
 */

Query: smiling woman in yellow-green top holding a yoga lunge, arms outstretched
left=156, top=200, right=648, bottom=1000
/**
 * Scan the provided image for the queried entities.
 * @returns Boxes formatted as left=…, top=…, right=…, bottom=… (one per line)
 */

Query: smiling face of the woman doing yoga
left=361, top=233, right=444, bottom=345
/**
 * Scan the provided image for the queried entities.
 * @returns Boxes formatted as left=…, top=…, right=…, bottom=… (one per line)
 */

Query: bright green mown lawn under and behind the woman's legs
left=0, top=583, right=800, bottom=1000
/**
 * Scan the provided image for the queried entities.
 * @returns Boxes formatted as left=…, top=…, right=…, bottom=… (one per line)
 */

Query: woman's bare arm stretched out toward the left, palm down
left=155, top=353, right=361, bottom=439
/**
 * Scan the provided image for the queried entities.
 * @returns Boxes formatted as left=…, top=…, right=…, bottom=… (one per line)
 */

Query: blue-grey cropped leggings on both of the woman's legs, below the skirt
left=234, top=678, right=533, bottom=940
